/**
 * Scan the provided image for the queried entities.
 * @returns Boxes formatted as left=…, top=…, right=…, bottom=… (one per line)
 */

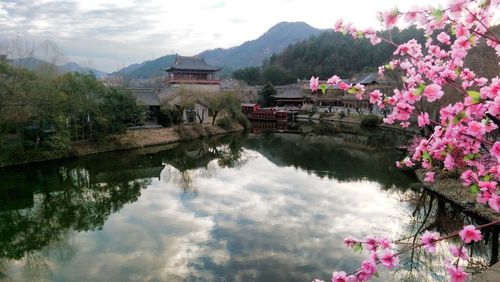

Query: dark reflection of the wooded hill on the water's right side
left=245, top=134, right=414, bottom=188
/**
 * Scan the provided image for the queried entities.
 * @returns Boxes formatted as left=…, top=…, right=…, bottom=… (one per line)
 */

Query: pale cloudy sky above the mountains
left=0, top=0, right=448, bottom=72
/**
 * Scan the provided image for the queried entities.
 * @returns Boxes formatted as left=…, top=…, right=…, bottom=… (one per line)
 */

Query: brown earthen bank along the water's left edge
left=0, top=123, right=244, bottom=167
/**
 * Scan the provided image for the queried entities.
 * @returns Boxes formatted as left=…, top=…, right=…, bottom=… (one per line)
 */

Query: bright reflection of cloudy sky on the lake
left=0, top=150, right=414, bottom=281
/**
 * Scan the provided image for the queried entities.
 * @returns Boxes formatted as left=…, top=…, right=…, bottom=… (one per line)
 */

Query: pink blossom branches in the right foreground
left=310, top=0, right=500, bottom=282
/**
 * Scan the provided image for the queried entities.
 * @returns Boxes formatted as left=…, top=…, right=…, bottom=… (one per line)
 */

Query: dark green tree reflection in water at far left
left=0, top=165, right=150, bottom=267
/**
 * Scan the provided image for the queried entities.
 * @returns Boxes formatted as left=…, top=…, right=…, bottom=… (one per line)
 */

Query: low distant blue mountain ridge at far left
left=12, top=57, right=107, bottom=78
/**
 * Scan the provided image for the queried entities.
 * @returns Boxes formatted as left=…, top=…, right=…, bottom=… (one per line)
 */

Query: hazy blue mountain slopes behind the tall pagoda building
left=117, top=22, right=323, bottom=79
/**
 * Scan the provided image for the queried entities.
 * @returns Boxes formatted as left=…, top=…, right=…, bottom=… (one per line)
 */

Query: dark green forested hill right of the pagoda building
left=233, top=27, right=425, bottom=85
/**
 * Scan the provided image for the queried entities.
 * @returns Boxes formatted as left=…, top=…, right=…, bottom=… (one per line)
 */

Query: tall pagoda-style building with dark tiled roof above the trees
left=165, top=55, right=221, bottom=91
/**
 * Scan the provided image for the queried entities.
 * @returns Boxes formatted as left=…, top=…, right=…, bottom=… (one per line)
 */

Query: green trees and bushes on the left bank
left=0, top=60, right=145, bottom=163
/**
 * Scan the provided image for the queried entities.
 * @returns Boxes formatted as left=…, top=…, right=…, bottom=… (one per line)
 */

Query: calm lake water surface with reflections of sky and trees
left=0, top=125, right=498, bottom=281
